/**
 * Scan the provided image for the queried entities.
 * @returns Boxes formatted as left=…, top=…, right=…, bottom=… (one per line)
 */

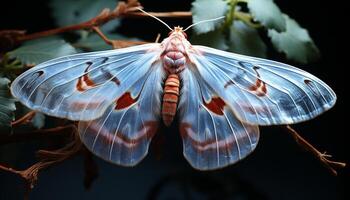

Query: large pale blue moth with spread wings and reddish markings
left=11, top=11, right=336, bottom=170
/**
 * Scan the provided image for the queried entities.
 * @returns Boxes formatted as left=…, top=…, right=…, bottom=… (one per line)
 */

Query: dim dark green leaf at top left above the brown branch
left=50, top=0, right=119, bottom=31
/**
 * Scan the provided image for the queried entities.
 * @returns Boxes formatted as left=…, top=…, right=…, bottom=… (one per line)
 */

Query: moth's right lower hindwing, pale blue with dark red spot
left=178, top=68, right=259, bottom=170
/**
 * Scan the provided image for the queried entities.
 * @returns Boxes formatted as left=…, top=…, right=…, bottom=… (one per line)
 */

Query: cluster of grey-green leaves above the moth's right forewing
left=192, top=0, right=319, bottom=61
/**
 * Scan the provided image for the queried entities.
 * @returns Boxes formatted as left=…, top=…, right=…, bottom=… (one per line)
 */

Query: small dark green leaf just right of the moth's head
left=191, top=30, right=228, bottom=50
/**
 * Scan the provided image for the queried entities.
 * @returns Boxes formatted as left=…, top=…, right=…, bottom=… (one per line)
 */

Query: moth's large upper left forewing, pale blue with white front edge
left=11, top=43, right=159, bottom=120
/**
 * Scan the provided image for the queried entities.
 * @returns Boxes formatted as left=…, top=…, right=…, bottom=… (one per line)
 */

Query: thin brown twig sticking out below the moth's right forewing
left=285, top=126, right=346, bottom=176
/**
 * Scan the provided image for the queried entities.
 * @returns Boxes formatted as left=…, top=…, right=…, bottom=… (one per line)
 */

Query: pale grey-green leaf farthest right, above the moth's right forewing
left=268, top=15, right=320, bottom=63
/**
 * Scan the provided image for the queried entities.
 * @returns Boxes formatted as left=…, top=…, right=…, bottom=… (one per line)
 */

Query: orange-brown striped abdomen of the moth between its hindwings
left=162, top=74, right=180, bottom=126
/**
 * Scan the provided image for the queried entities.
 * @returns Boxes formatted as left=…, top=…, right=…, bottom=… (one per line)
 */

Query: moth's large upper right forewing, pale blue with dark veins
left=190, top=46, right=336, bottom=125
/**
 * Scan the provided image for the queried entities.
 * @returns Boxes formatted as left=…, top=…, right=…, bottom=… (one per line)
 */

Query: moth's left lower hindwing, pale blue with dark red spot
left=78, top=62, right=164, bottom=166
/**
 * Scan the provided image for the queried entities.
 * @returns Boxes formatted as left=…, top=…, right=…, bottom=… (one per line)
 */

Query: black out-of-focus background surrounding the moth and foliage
left=0, top=0, right=349, bottom=200
